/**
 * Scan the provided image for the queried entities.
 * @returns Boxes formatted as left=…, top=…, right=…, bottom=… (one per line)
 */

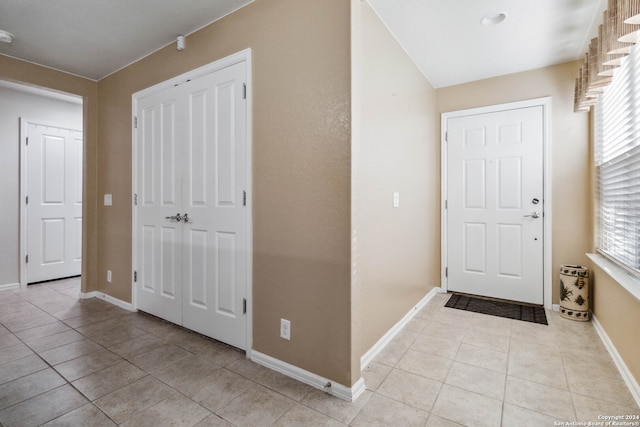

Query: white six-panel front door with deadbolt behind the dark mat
left=446, top=106, right=544, bottom=304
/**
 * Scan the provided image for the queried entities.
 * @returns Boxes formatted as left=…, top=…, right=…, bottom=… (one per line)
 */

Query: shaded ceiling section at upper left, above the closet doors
left=0, top=0, right=253, bottom=80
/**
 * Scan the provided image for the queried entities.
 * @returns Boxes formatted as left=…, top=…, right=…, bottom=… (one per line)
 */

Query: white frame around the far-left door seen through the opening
left=18, top=117, right=86, bottom=289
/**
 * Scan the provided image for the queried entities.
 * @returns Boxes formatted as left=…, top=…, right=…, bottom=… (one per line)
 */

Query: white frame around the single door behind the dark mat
left=440, top=97, right=553, bottom=309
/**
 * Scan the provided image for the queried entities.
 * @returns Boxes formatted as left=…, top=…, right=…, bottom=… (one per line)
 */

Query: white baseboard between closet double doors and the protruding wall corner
left=251, top=350, right=365, bottom=402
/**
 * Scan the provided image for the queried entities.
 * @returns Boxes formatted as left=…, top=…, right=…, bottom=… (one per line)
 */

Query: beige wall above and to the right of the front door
left=436, top=61, right=591, bottom=304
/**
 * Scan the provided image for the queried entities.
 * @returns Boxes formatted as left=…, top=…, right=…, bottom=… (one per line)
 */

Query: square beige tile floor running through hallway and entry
left=0, top=279, right=640, bottom=427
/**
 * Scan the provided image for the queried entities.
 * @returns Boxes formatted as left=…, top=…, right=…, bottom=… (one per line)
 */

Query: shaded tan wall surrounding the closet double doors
left=98, top=0, right=357, bottom=386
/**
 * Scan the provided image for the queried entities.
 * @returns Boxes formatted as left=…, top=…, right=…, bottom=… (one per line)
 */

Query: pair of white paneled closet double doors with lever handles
left=135, top=59, right=248, bottom=349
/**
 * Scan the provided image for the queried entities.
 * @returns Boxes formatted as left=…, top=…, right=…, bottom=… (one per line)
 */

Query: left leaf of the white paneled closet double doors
left=135, top=83, right=186, bottom=324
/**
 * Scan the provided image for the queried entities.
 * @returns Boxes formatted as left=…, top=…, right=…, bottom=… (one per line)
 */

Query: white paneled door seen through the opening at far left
left=26, top=122, right=82, bottom=283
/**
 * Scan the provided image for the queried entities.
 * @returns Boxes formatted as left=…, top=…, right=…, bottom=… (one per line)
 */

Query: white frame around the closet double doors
left=131, top=48, right=253, bottom=357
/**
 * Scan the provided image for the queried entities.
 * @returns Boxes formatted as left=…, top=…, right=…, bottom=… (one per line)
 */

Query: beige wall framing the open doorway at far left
left=0, top=55, right=98, bottom=292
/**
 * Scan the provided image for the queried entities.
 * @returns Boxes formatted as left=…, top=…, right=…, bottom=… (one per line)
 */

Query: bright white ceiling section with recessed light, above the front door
left=368, top=0, right=607, bottom=88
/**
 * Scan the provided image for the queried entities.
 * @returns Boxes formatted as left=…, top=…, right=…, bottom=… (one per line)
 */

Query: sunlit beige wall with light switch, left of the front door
left=352, top=0, right=440, bottom=370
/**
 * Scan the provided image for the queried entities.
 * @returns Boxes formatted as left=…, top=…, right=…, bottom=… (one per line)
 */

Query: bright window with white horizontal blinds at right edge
left=595, top=41, right=640, bottom=273
